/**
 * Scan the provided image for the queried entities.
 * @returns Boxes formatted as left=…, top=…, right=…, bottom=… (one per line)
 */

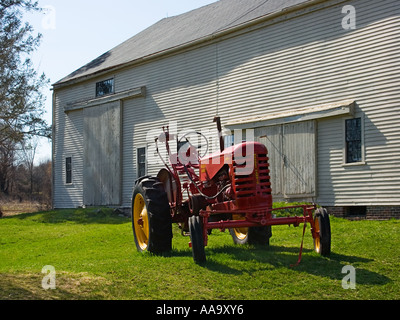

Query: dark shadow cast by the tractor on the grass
left=169, top=246, right=392, bottom=285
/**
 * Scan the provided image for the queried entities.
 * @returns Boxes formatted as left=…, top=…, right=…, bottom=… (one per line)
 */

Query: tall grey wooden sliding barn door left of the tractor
left=83, top=102, right=121, bottom=206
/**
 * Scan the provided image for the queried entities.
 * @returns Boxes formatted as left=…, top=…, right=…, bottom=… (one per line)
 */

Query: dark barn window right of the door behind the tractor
left=346, top=118, right=363, bottom=163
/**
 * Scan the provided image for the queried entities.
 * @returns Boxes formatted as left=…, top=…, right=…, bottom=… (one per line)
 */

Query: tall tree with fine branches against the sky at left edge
left=0, top=0, right=51, bottom=194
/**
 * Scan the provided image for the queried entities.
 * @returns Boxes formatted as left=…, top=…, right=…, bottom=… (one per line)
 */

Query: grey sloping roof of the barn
left=54, top=0, right=312, bottom=86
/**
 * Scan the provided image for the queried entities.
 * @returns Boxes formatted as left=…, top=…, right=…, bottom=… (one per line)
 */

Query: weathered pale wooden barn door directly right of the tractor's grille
left=255, top=121, right=316, bottom=199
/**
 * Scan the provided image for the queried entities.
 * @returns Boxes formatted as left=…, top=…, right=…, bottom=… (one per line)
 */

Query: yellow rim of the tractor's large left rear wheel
left=133, top=194, right=150, bottom=251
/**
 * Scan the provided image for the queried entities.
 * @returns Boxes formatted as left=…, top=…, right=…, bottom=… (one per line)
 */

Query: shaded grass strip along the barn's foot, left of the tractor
left=3, top=208, right=130, bottom=225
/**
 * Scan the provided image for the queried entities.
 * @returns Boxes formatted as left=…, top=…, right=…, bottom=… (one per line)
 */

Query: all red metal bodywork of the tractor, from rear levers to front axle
left=156, top=122, right=319, bottom=262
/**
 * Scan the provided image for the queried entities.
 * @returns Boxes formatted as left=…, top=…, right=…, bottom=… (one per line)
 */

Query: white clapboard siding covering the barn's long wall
left=54, top=0, right=400, bottom=207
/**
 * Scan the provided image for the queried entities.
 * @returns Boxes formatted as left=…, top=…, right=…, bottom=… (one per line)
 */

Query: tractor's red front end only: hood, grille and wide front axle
left=200, top=142, right=318, bottom=245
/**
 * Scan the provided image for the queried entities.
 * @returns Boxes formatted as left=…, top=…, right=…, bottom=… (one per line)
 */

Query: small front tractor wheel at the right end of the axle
left=314, top=208, right=332, bottom=257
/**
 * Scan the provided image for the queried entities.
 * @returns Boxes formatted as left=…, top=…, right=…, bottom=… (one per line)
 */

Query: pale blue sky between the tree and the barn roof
left=26, top=0, right=216, bottom=162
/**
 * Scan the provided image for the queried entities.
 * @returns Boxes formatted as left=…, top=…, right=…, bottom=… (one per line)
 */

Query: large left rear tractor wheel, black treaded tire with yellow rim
left=132, top=177, right=172, bottom=253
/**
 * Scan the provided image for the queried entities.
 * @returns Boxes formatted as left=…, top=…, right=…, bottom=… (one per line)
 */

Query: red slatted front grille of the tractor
left=233, top=154, right=272, bottom=199
